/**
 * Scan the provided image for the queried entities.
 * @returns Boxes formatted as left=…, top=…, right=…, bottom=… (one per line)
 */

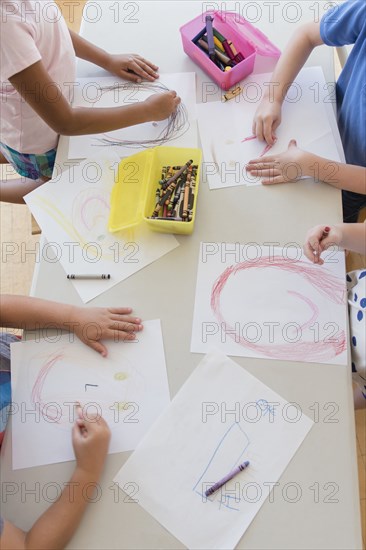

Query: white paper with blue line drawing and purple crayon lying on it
left=115, top=352, right=313, bottom=549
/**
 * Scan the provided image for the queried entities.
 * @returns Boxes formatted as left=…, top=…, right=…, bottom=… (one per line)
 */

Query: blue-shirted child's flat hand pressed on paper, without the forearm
left=245, top=139, right=307, bottom=184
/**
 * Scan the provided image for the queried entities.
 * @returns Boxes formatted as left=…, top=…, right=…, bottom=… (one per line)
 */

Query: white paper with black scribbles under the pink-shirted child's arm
left=69, top=73, right=197, bottom=159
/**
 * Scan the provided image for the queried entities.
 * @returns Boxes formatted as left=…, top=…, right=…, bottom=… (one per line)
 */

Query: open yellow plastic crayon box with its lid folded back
left=108, top=147, right=202, bottom=235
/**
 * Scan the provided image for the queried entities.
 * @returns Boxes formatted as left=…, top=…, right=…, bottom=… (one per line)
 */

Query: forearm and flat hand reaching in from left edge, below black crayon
left=0, top=295, right=142, bottom=357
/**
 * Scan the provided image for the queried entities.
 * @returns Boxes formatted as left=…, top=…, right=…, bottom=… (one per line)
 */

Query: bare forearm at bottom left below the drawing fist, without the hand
left=24, top=468, right=99, bottom=550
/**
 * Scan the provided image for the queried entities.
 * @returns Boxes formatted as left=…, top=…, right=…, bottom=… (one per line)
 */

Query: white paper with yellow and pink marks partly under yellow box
left=25, top=160, right=179, bottom=302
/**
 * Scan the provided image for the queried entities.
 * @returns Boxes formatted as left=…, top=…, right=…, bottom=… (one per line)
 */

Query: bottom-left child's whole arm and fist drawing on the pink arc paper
left=0, top=407, right=110, bottom=550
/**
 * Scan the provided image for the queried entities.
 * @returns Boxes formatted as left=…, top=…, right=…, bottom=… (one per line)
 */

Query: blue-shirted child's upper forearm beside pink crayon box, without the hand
left=266, top=23, right=322, bottom=104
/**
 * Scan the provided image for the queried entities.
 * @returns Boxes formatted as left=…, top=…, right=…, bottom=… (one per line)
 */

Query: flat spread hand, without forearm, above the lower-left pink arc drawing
left=70, top=307, right=142, bottom=357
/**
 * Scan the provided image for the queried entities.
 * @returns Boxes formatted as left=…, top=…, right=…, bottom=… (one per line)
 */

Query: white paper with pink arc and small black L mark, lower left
left=11, top=320, right=170, bottom=469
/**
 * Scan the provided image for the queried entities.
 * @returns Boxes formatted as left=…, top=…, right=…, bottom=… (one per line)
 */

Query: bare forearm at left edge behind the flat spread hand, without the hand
left=0, top=294, right=75, bottom=330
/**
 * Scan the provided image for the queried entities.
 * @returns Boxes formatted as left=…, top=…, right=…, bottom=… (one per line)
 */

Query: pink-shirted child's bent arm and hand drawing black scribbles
left=9, top=61, right=180, bottom=136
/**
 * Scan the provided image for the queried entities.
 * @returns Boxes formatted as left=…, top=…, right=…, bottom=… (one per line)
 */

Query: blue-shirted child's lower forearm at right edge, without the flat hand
left=301, top=152, right=366, bottom=194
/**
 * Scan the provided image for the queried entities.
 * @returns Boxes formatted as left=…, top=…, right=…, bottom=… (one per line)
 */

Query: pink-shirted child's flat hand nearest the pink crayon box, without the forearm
left=105, top=53, right=159, bottom=82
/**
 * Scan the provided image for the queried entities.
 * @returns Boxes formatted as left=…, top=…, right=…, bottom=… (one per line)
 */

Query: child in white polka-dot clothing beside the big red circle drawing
left=304, top=223, right=366, bottom=408
